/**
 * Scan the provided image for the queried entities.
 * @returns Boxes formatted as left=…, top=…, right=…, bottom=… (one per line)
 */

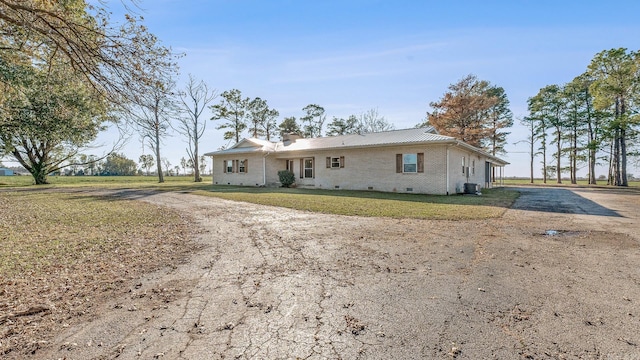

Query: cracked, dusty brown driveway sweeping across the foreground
left=36, top=188, right=640, bottom=359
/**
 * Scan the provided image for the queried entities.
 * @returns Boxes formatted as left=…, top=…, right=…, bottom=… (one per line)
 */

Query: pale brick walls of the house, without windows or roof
left=213, top=145, right=498, bottom=195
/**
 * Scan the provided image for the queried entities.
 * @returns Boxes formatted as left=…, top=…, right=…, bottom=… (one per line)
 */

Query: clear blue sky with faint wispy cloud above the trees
left=91, top=0, right=640, bottom=176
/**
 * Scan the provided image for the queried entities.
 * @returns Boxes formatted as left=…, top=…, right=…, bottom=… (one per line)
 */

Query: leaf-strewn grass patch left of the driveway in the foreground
left=0, top=187, right=195, bottom=358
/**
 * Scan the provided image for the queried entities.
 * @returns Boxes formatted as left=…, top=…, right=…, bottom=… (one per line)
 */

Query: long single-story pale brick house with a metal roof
left=205, top=127, right=508, bottom=195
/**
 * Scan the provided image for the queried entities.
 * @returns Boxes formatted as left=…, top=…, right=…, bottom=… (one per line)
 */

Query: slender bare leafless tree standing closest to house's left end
left=177, top=74, right=217, bottom=182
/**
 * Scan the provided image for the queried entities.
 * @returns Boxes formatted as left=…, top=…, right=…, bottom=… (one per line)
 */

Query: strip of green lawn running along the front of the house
left=0, top=176, right=518, bottom=220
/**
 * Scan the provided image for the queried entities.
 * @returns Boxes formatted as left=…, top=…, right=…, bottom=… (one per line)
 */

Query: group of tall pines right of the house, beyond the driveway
left=522, top=48, right=640, bottom=186
